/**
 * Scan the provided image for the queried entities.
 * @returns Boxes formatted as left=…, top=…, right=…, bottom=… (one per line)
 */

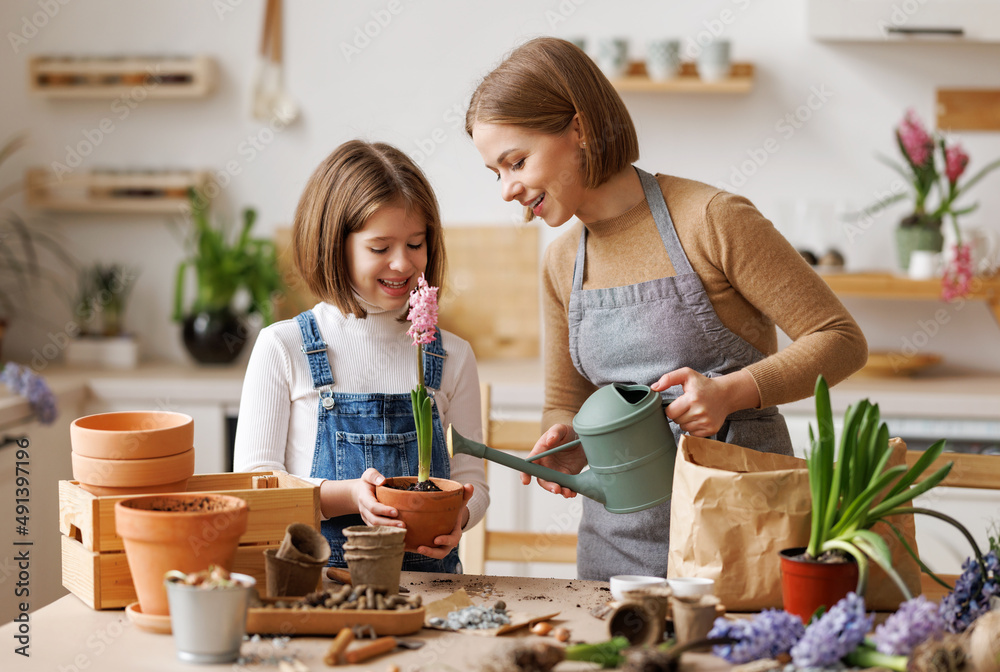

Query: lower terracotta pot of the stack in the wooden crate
left=70, top=448, right=194, bottom=488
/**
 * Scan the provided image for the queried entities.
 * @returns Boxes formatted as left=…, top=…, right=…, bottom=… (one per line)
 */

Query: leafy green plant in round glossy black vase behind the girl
left=173, top=189, right=284, bottom=364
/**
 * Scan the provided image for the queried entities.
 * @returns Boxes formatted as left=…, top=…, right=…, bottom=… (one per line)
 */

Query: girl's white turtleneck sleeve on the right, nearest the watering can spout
left=442, top=343, right=490, bottom=530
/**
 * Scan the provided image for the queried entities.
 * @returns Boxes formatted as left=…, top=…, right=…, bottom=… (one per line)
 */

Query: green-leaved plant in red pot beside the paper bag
left=781, top=376, right=979, bottom=621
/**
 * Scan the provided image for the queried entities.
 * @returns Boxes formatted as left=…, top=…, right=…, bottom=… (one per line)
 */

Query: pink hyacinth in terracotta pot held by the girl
left=375, top=274, right=463, bottom=548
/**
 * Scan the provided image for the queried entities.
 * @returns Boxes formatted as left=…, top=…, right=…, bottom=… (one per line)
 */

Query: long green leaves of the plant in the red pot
left=806, top=376, right=952, bottom=599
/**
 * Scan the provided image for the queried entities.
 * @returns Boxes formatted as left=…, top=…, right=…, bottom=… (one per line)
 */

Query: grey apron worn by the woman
left=569, top=168, right=792, bottom=581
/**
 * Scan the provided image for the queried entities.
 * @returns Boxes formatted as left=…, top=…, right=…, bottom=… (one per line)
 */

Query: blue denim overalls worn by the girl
left=295, top=310, right=461, bottom=574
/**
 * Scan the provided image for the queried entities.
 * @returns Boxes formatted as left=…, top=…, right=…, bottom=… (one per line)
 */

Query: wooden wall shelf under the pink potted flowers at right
left=822, top=273, right=1000, bottom=325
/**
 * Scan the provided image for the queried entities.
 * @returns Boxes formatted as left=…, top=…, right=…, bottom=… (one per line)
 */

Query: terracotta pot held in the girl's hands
left=375, top=476, right=462, bottom=549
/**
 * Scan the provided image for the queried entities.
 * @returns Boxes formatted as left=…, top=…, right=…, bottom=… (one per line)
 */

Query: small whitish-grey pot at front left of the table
left=163, top=574, right=256, bottom=664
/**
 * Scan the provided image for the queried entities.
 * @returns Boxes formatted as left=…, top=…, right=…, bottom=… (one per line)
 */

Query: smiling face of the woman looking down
left=472, top=119, right=585, bottom=227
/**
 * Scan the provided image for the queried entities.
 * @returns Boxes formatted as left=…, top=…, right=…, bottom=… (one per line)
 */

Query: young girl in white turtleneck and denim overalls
left=234, top=140, right=489, bottom=572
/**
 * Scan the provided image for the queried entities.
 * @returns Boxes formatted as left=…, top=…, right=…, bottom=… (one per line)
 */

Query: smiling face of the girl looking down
left=346, top=205, right=427, bottom=310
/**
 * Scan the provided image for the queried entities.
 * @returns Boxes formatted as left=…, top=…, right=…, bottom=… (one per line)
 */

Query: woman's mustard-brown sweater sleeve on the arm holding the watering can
left=704, top=192, right=868, bottom=407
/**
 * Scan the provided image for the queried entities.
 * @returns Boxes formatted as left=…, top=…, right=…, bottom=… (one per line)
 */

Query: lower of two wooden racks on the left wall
left=25, top=168, right=210, bottom=213
